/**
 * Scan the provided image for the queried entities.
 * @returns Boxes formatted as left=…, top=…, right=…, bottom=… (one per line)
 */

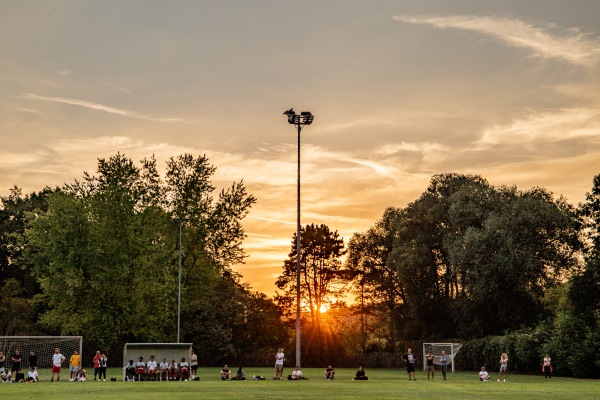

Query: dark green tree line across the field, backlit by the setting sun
left=0, top=154, right=600, bottom=376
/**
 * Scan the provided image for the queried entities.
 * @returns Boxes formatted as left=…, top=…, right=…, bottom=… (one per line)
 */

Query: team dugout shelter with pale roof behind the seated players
left=123, top=343, right=193, bottom=380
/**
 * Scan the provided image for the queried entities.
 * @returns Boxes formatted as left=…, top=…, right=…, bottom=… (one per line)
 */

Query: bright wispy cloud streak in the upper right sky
left=394, top=15, right=600, bottom=67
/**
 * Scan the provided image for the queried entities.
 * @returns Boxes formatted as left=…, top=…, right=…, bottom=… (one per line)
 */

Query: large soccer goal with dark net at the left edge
left=0, top=336, right=83, bottom=370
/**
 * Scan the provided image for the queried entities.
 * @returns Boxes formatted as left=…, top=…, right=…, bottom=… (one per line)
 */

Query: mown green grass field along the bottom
left=0, top=367, right=600, bottom=400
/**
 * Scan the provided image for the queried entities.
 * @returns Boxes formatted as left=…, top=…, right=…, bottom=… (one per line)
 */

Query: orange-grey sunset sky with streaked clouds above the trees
left=0, top=0, right=600, bottom=295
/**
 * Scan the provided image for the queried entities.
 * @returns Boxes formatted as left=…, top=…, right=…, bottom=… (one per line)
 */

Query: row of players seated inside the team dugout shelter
left=125, top=356, right=191, bottom=382
